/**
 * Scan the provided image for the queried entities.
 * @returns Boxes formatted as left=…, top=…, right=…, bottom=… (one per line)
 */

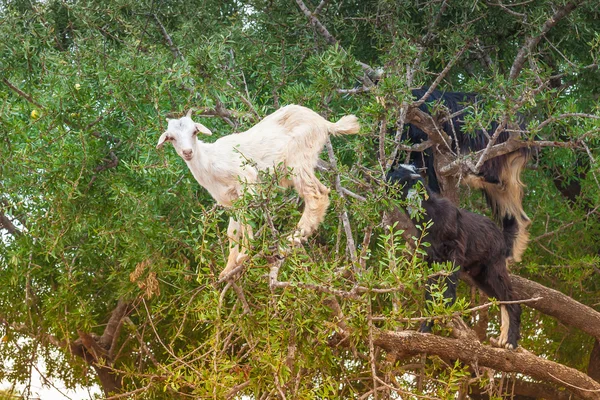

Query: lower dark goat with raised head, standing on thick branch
left=387, top=164, right=521, bottom=349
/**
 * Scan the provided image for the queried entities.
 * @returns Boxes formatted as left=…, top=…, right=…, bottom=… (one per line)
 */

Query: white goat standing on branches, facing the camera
left=156, top=105, right=360, bottom=278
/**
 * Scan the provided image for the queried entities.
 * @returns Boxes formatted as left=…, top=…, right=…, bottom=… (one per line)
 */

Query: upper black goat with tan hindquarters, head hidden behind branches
left=403, top=88, right=531, bottom=261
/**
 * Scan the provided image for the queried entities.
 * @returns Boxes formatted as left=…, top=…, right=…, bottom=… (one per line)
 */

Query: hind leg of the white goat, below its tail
left=288, top=174, right=329, bottom=246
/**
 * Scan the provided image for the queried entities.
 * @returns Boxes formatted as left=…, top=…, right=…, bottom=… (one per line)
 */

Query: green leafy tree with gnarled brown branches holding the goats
left=0, top=0, right=600, bottom=400
